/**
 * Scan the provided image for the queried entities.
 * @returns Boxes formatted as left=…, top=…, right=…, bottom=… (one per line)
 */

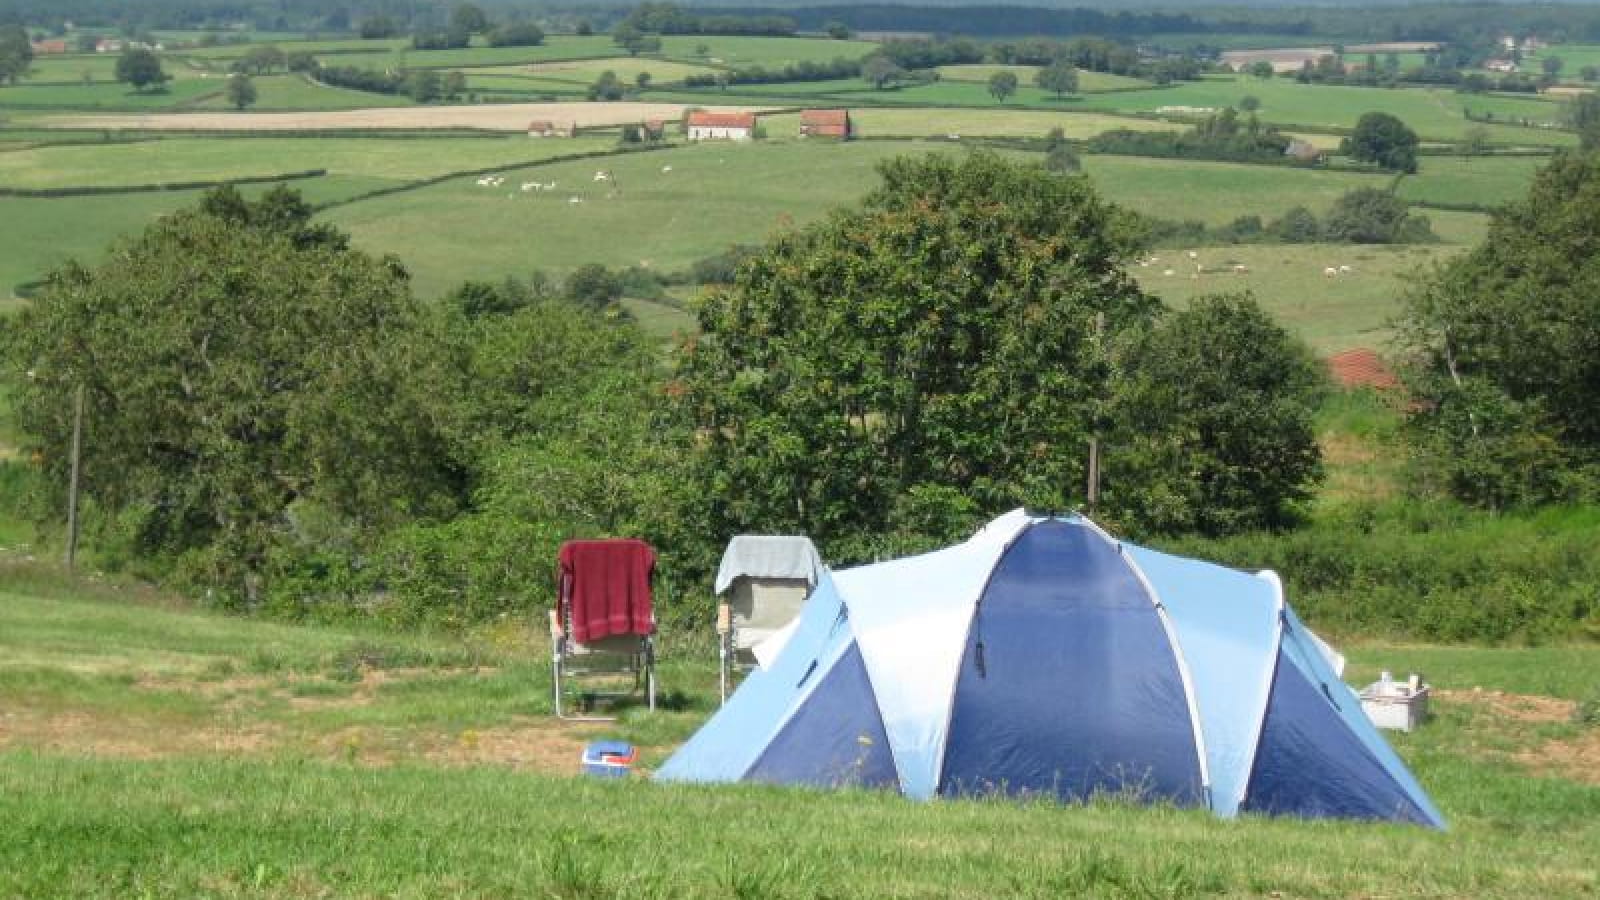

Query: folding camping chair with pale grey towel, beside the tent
left=715, top=535, right=822, bottom=703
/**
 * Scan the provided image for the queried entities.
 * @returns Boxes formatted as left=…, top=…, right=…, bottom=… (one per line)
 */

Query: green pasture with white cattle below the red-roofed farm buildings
left=328, top=141, right=930, bottom=296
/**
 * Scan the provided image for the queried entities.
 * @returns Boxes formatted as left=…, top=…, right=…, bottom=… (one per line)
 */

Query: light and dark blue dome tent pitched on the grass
left=658, top=511, right=1443, bottom=828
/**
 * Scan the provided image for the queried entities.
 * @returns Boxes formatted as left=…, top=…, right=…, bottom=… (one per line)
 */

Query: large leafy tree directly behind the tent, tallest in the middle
left=672, top=152, right=1155, bottom=559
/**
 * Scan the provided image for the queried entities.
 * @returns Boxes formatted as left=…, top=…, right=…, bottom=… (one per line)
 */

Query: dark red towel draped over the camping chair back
left=562, top=540, right=656, bottom=644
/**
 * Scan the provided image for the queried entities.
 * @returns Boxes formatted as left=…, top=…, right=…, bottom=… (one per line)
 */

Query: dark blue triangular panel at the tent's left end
left=746, top=644, right=899, bottom=788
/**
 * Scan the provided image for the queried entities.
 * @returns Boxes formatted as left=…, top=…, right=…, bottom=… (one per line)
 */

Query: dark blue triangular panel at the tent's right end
left=1240, top=653, right=1437, bottom=826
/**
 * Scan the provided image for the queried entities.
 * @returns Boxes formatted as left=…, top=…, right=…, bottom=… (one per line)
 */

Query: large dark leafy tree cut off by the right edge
left=1400, top=154, right=1600, bottom=508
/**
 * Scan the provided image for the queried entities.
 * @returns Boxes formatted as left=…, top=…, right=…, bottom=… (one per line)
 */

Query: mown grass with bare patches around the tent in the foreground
left=0, top=564, right=1600, bottom=897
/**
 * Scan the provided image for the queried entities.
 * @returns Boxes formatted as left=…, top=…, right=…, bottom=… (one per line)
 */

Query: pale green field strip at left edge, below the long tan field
left=0, top=135, right=616, bottom=187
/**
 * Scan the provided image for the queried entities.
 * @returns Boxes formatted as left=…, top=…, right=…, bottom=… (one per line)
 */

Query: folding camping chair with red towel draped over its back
left=550, top=540, right=656, bottom=722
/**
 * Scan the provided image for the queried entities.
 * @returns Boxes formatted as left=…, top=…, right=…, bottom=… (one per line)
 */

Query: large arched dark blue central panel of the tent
left=939, top=520, right=1205, bottom=804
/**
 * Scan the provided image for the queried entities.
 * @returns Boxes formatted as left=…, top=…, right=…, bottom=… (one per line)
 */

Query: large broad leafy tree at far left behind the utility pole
left=5, top=187, right=458, bottom=605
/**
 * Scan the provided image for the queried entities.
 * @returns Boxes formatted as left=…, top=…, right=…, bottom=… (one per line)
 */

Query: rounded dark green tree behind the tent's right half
left=1104, top=295, right=1323, bottom=535
